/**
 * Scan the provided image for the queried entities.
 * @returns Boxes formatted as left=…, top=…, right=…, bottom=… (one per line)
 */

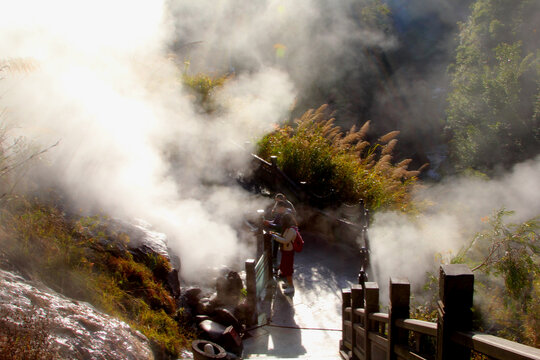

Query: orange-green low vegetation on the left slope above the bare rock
left=0, top=197, right=192, bottom=356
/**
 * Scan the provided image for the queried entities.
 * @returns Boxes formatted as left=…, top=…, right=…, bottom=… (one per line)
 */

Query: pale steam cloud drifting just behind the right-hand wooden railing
left=370, top=157, right=540, bottom=299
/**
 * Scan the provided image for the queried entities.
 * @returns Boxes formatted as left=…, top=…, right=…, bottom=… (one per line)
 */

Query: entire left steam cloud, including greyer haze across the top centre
left=0, top=0, right=393, bottom=278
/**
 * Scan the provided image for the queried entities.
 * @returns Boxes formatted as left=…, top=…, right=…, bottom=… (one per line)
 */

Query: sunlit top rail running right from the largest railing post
left=451, top=331, right=540, bottom=360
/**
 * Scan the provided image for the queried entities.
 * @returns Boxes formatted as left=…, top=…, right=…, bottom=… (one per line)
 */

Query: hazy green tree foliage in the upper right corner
left=447, top=0, right=540, bottom=171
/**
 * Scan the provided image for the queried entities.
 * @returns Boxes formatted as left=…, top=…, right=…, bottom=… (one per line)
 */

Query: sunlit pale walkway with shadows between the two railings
left=244, top=233, right=360, bottom=359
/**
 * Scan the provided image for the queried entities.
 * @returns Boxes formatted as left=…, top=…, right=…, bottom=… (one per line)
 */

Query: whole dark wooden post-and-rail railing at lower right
left=340, top=265, right=540, bottom=360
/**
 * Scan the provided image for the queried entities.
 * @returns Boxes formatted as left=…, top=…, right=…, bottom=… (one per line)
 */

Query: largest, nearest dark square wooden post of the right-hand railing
left=436, top=264, right=474, bottom=360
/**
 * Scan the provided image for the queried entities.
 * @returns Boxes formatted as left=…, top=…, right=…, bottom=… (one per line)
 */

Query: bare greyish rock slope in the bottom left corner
left=0, top=270, right=154, bottom=360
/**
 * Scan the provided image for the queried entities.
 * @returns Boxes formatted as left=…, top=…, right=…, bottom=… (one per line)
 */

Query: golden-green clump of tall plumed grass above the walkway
left=258, top=105, right=420, bottom=210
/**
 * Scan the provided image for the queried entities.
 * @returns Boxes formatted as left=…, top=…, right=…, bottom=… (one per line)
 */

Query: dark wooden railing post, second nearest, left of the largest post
left=387, top=278, right=411, bottom=360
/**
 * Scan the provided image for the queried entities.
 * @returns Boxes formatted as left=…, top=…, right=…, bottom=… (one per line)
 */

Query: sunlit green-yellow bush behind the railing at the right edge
left=454, top=209, right=540, bottom=347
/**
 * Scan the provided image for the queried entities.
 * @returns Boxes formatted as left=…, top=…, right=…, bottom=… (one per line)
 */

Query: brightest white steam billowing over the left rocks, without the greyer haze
left=0, top=0, right=295, bottom=279
